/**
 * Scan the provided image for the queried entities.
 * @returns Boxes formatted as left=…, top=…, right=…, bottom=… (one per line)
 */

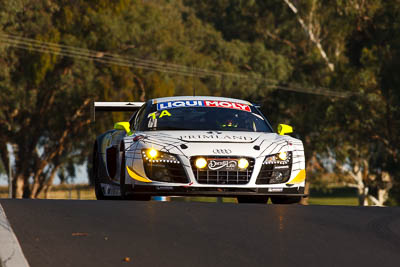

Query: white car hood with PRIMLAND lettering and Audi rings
left=135, top=131, right=301, bottom=158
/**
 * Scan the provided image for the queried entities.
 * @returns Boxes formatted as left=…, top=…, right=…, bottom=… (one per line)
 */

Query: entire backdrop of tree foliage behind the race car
left=0, top=0, right=400, bottom=203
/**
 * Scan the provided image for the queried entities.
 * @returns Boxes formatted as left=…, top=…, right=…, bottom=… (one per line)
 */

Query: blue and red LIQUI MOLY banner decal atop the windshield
left=157, top=100, right=251, bottom=112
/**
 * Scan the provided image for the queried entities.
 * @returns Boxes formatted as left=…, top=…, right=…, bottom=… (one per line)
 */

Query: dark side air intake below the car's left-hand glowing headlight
left=143, top=162, right=188, bottom=183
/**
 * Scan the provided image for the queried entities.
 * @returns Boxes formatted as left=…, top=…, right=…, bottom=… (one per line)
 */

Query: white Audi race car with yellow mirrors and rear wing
left=92, top=96, right=306, bottom=204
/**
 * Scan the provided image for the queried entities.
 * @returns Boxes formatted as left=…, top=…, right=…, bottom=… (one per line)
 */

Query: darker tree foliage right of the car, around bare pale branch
left=185, top=0, right=400, bottom=204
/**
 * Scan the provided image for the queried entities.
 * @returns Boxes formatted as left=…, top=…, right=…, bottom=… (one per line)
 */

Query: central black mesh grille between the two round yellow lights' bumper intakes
left=190, top=156, right=254, bottom=185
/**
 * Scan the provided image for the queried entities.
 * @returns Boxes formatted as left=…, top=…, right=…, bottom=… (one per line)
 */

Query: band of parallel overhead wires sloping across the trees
left=0, top=33, right=351, bottom=97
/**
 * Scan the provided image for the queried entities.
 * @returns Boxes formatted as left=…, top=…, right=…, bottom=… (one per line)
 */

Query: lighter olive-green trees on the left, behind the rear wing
left=0, top=0, right=294, bottom=197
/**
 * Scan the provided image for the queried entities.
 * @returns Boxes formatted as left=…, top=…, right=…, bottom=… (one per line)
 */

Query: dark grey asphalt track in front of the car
left=0, top=200, right=400, bottom=267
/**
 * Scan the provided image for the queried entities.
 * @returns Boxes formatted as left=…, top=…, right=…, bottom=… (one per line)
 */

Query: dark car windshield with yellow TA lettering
left=139, top=101, right=272, bottom=132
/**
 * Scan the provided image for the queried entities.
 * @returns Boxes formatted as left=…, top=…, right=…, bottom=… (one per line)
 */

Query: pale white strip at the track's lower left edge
left=0, top=204, right=29, bottom=267
